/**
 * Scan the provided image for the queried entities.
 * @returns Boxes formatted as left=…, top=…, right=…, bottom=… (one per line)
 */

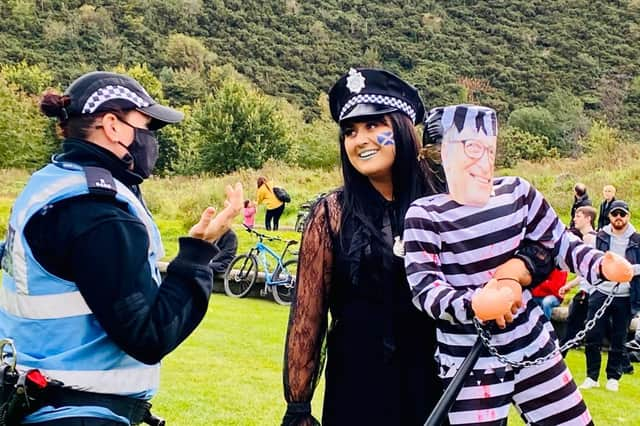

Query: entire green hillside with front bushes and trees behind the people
left=0, top=0, right=640, bottom=175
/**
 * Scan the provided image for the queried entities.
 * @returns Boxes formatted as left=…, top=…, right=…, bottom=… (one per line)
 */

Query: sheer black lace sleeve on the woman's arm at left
left=283, top=193, right=340, bottom=425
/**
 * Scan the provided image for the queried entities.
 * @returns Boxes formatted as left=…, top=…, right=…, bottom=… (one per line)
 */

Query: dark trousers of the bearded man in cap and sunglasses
left=585, top=291, right=631, bottom=381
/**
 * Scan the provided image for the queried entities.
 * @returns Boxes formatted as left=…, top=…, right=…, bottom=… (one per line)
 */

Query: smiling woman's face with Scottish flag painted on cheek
left=342, top=116, right=396, bottom=182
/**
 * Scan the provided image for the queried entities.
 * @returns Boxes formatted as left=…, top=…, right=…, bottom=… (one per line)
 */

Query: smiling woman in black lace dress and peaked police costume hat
left=284, top=69, right=440, bottom=425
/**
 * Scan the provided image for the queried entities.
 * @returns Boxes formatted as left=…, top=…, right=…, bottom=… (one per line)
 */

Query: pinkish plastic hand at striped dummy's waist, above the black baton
left=471, top=279, right=522, bottom=327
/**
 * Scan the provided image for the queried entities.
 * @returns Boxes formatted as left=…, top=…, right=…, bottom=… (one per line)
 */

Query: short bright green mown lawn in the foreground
left=152, top=294, right=640, bottom=426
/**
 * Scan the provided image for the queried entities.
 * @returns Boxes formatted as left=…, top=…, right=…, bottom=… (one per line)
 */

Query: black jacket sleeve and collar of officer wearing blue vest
left=25, top=139, right=217, bottom=364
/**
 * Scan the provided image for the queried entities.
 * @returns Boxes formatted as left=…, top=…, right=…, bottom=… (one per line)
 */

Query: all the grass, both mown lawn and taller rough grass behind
left=0, top=145, right=640, bottom=426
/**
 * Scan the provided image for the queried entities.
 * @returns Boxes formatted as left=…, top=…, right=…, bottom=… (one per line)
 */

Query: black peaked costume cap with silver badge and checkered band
left=329, top=68, right=424, bottom=124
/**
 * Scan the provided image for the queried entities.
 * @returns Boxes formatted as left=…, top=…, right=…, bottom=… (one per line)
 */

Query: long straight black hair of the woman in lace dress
left=340, top=112, right=433, bottom=241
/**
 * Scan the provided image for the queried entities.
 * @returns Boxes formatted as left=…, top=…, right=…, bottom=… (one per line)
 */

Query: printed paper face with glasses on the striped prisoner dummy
left=442, top=128, right=497, bottom=206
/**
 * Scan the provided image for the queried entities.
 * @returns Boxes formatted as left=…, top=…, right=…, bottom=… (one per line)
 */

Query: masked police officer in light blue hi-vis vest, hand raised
left=0, top=72, right=244, bottom=425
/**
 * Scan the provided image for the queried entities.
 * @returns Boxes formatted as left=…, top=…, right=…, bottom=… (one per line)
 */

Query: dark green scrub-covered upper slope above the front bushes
left=0, top=0, right=640, bottom=121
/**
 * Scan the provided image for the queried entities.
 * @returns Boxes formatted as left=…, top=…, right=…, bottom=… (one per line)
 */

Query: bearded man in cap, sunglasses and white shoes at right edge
left=580, top=200, right=640, bottom=392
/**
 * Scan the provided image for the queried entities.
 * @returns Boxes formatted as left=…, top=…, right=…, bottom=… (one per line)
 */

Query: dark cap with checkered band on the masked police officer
left=64, top=71, right=184, bottom=130
